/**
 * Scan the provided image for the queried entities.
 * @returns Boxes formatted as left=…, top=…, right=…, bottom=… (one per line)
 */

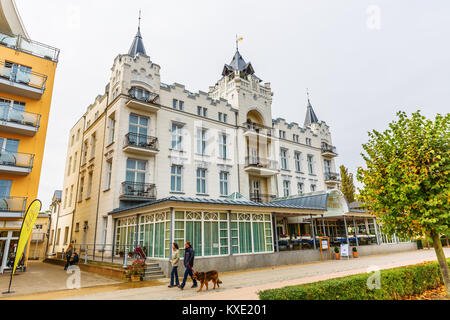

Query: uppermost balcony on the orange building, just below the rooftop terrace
left=0, top=61, right=47, bottom=100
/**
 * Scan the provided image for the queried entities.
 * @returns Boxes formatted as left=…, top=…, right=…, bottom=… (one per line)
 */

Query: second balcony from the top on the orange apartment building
left=0, top=102, right=41, bottom=136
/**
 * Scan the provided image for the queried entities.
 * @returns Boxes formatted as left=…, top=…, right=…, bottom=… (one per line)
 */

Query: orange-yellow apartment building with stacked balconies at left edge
left=0, top=1, right=59, bottom=273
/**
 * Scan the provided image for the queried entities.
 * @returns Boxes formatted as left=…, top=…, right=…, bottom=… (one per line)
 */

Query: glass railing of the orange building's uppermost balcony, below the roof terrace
left=0, top=61, right=47, bottom=91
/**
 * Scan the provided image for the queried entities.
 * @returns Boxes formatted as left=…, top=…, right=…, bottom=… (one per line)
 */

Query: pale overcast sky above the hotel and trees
left=16, top=0, right=450, bottom=209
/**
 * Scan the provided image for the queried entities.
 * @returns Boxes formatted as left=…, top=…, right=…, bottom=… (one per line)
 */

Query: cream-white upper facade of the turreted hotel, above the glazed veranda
left=52, top=28, right=338, bottom=252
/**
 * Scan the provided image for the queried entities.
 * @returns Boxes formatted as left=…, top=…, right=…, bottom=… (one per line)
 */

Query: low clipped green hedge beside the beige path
left=259, top=259, right=450, bottom=300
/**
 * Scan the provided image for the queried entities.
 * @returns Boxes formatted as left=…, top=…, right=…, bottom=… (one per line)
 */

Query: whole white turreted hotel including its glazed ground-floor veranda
left=49, top=21, right=406, bottom=276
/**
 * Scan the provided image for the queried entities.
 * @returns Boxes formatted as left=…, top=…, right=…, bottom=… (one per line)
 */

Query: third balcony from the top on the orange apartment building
left=0, top=149, right=34, bottom=176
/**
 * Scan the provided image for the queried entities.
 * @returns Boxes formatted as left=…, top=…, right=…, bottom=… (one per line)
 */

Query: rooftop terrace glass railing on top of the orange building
left=0, top=33, right=59, bottom=62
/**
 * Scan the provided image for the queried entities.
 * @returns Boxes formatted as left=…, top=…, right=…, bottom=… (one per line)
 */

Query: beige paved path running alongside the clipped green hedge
left=51, top=248, right=450, bottom=300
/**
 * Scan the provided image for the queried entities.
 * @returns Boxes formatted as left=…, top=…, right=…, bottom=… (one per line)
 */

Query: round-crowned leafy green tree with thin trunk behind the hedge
left=357, top=111, right=450, bottom=296
